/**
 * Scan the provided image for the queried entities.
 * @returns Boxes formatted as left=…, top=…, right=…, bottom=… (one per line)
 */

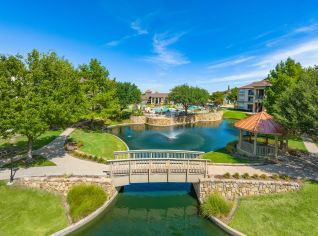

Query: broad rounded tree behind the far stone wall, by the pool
left=168, top=84, right=209, bottom=115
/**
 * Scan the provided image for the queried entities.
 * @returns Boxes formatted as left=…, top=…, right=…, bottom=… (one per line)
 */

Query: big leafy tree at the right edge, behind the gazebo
left=273, top=67, right=318, bottom=135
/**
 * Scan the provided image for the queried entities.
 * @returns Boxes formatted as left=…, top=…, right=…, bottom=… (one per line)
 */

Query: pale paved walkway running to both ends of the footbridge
left=0, top=128, right=318, bottom=180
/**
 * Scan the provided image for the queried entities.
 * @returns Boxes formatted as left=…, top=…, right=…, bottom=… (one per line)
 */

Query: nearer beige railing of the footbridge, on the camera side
left=107, top=158, right=208, bottom=177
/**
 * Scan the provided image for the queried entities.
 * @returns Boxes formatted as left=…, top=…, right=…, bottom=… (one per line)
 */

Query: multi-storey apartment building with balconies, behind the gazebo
left=237, top=80, right=271, bottom=112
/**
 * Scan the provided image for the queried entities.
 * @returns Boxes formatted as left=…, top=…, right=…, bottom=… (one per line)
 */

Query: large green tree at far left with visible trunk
left=0, top=50, right=83, bottom=159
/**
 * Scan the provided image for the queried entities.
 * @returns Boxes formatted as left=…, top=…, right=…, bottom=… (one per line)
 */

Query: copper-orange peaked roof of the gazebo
left=234, top=111, right=283, bottom=135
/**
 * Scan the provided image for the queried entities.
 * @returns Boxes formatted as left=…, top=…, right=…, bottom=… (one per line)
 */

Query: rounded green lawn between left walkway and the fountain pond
left=70, top=129, right=127, bottom=159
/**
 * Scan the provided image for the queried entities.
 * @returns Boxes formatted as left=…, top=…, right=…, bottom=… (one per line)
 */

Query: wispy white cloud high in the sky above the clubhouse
left=146, top=34, right=190, bottom=69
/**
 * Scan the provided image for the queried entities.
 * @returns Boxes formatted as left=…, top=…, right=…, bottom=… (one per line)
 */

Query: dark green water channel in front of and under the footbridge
left=71, top=183, right=227, bottom=236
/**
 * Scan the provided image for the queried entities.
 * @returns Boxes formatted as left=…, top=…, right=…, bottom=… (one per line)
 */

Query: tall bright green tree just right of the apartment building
left=264, top=58, right=303, bottom=114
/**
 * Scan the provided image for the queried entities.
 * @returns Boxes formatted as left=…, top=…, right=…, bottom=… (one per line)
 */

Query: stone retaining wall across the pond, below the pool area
left=139, top=111, right=223, bottom=126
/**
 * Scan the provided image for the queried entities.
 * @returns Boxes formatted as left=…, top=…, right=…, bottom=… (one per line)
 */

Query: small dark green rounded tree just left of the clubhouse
left=116, top=82, right=141, bottom=110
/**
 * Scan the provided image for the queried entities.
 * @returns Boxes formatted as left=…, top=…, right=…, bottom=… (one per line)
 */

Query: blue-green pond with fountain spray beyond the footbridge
left=110, top=120, right=239, bottom=152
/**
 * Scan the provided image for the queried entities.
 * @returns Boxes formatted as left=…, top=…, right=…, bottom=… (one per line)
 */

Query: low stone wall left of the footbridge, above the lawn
left=16, top=176, right=116, bottom=197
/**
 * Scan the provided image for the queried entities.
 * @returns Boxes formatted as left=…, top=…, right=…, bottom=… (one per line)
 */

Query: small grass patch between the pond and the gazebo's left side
left=203, top=148, right=249, bottom=163
